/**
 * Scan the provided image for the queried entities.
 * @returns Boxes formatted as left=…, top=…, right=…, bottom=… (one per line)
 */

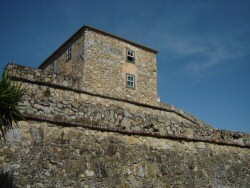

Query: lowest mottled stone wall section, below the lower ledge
left=0, top=121, right=250, bottom=188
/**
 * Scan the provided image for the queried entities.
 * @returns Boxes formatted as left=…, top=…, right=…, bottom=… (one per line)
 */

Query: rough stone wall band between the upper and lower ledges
left=7, top=79, right=250, bottom=146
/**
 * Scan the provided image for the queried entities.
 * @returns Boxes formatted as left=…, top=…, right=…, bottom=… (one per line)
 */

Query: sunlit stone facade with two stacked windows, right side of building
left=83, top=30, right=158, bottom=104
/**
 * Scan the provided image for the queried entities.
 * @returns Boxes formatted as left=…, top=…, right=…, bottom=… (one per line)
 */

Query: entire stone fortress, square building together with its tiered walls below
left=0, top=26, right=250, bottom=188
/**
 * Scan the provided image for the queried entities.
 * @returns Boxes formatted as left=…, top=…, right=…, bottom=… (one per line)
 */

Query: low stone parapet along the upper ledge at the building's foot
left=6, top=64, right=208, bottom=125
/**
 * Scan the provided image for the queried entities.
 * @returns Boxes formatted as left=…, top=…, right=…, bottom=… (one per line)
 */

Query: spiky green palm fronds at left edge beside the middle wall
left=0, top=72, right=24, bottom=139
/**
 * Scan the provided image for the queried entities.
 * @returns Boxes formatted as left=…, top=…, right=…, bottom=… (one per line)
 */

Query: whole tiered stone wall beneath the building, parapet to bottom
left=0, top=65, right=250, bottom=187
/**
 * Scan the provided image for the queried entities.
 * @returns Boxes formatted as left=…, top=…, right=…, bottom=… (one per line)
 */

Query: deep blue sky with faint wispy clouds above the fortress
left=0, top=0, right=250, bottom=133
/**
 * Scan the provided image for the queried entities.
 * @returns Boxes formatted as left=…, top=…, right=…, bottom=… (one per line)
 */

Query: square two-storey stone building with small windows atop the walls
left=39, top=26, right=158, bottom=105
